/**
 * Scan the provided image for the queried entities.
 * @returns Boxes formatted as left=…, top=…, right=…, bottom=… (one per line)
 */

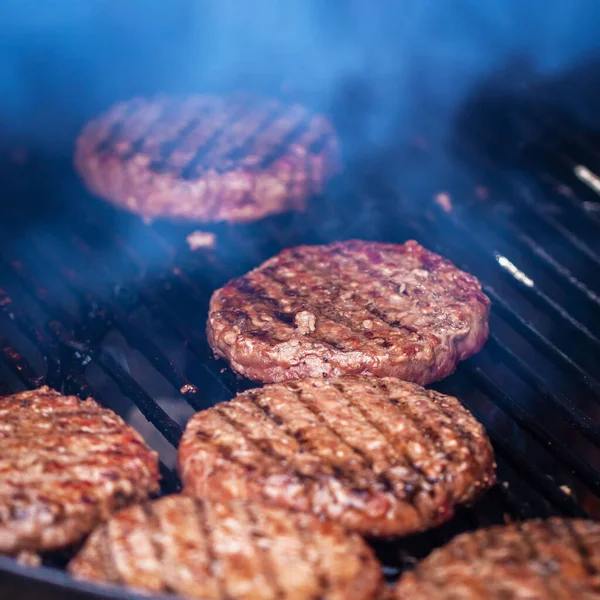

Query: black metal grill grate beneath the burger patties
left=0, top=104, right=600, bottom=598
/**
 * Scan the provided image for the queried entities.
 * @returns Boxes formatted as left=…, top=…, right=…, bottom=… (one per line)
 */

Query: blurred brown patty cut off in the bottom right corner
left=394, top=518, right=600, bottom=600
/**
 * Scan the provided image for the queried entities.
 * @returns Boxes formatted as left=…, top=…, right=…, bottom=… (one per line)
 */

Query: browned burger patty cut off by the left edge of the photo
left=0, top=387, right=159, bottom=555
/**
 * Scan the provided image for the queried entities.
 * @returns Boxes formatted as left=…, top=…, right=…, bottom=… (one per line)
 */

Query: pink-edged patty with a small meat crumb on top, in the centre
left=207, top=240, right=490, bottom=385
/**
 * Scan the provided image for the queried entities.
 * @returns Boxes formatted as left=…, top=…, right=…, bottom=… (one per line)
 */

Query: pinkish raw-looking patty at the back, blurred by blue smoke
left=75, top=95, right=339, bottom=222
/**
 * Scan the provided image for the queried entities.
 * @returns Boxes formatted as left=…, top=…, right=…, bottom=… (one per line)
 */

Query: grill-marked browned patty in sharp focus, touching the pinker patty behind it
left=179, top=376, right=495, bottom=536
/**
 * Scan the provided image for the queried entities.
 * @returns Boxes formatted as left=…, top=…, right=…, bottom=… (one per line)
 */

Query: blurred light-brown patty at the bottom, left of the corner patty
left=69, top=495, right=382, bottom=600
